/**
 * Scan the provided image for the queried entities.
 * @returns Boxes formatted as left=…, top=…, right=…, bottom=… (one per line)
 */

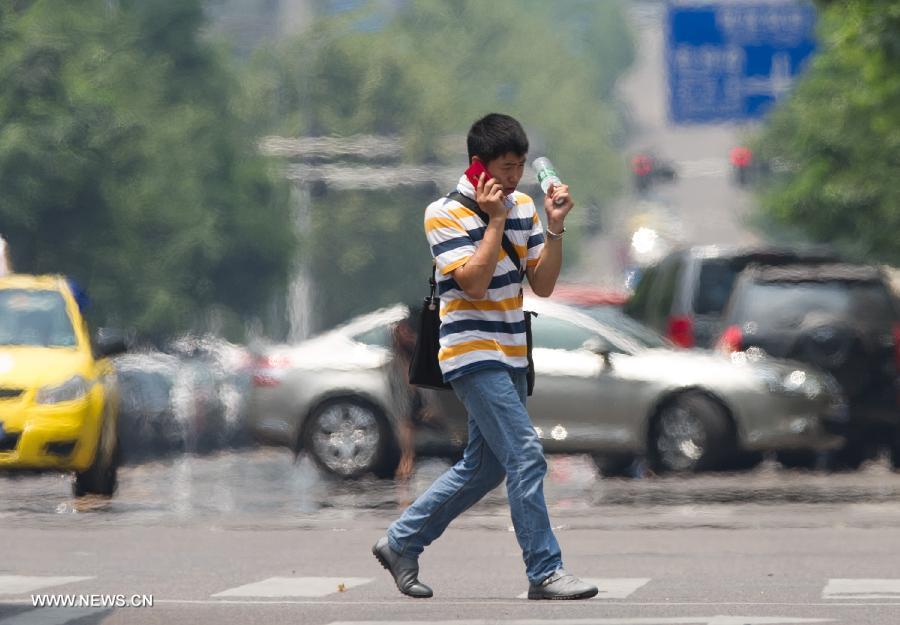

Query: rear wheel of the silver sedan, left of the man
left=303, top=397, right=399, bottom=478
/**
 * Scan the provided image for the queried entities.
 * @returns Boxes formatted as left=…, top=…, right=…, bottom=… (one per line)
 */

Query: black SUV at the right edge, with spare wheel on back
left=719, top=264, right=900, bottom=467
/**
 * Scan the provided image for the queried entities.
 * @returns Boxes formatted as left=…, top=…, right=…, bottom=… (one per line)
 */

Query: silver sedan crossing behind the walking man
left=244, top=298, right=846, bottom=477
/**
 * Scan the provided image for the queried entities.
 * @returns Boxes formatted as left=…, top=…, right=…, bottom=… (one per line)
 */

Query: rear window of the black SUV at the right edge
left=734, top=281, right=895, bottom=326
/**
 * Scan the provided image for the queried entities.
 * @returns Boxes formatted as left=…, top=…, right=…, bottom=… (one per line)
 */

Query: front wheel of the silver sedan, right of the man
left=649, top=393, right=734, bottom=473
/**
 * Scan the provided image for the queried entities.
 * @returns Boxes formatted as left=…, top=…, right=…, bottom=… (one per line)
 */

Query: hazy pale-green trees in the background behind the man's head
left=244, top=0, right=633, bottom=325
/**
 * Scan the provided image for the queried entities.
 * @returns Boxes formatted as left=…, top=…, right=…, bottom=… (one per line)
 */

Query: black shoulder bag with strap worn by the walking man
left=409, top=191, right=537, bottom=396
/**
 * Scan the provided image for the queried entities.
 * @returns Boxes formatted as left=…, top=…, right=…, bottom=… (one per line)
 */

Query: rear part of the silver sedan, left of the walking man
left=247, top=305, right=458, bottom=477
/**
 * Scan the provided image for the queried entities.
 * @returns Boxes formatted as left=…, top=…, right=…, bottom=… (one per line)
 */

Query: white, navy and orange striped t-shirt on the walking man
left=425, top=176, right=544, bottom=382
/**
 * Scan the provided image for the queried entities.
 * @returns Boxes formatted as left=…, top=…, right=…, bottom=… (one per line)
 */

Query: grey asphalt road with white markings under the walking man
left=0, top=450, right=900, bottom=625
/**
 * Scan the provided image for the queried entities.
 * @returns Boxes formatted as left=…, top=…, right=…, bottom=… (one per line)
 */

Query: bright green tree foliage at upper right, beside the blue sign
left=757, top=0, right=900, bottom=264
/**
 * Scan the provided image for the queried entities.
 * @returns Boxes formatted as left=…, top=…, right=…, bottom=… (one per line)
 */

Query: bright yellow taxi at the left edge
left=0, top=274, right=125, bottom=496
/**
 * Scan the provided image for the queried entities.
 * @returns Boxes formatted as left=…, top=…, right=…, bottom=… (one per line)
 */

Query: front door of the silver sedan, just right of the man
left=528, top=313, right=642, bottom=452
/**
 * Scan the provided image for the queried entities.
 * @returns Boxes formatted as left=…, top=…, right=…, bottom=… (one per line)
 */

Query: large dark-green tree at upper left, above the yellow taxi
left=0, top=0, right=296, bottom=339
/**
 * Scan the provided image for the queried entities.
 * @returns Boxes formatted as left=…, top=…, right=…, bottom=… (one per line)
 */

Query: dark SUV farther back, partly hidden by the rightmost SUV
left=625, top=246, right=839, bottom=347
